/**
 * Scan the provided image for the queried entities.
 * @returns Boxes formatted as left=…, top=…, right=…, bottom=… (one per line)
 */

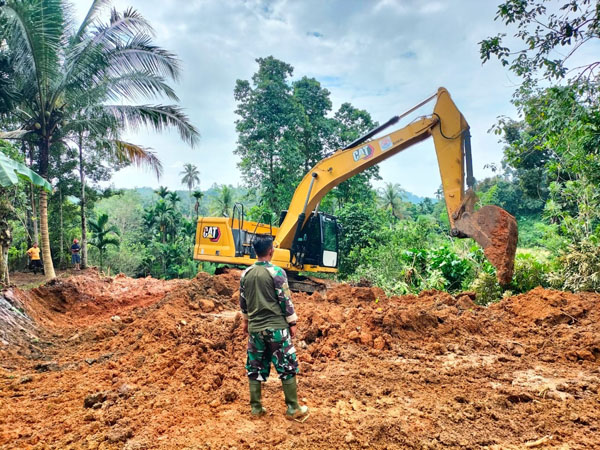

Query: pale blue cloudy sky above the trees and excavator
left=75, top=0, right=519, bottom=196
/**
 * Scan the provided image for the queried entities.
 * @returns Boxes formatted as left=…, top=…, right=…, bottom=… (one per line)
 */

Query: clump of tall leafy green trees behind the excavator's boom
left=234, top=56, right=379, bottom=217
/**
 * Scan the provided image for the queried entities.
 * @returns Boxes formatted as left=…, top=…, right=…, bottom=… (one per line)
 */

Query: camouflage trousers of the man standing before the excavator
left=246, top=328, right=298, bottom=381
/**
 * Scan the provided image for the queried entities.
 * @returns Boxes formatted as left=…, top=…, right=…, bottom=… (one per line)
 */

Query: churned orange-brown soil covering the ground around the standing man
left=0, top=271, right=600, bottom=450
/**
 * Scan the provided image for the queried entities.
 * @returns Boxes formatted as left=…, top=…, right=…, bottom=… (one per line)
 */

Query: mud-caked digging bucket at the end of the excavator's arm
left=454, top=191, right=519, bottom=285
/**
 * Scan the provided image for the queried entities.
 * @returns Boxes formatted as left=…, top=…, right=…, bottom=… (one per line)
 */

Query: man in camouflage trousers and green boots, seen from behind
left=240, top=236, right=308, bottom=419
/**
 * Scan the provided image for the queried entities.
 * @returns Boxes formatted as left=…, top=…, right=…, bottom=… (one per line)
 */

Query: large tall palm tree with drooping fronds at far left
left=0, top=0, right=198, bottom=278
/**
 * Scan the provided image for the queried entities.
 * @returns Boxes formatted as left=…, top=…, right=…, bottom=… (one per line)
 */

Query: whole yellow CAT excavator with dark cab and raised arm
left=194, top=88, right=518, bottom=291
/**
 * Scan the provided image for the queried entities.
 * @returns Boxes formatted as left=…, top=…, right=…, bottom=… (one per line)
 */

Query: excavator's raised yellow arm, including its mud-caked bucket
left=275, top=88, right=517, bottom=284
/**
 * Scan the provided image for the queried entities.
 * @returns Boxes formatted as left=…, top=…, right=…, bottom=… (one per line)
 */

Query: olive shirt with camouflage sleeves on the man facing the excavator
left=240, top=261, right=298, bottom=332
